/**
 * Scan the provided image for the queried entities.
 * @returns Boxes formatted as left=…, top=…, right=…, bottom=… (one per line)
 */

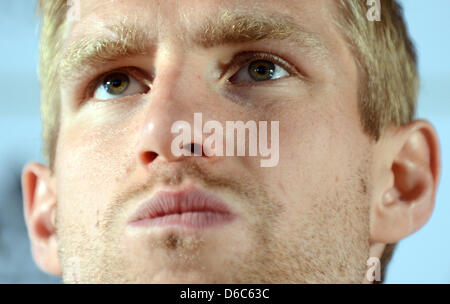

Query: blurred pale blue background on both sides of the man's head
left=0, top=0, right=450, bottom=283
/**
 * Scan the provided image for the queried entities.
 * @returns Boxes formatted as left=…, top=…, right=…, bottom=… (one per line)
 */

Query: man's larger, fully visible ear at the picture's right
left=370, top=120, right=441, bottom=245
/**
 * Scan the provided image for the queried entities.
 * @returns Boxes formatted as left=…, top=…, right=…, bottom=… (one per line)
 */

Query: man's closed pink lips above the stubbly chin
left=129, top=187, right=235, bottom=229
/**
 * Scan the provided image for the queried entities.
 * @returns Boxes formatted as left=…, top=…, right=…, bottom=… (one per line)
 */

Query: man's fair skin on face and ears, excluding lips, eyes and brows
left=22, top=0, right=440, bottom=283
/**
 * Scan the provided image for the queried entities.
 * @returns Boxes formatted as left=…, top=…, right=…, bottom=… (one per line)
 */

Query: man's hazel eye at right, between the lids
left=229, top=55, right=290, bottom=83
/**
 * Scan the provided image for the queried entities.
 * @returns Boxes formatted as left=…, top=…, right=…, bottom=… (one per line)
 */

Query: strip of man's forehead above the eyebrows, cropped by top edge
left=69, top=0, right=337, bottom=47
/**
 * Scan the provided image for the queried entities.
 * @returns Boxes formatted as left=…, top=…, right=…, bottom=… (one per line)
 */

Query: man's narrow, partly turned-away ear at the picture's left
left=22, top=163, right=61, bottom=275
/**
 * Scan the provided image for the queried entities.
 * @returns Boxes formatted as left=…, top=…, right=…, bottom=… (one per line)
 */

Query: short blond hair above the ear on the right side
left=336, top=0, right=419, bottom=140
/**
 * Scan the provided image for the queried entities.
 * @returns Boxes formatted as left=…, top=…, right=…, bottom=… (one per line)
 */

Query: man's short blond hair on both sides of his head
left=39, top=0, right=418, bottom=280
